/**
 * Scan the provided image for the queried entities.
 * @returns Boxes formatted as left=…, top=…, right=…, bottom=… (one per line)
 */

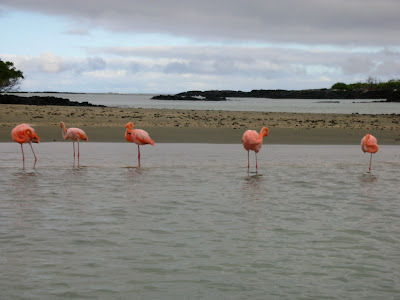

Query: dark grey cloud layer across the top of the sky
left=2, top=0, right=400, bottom=46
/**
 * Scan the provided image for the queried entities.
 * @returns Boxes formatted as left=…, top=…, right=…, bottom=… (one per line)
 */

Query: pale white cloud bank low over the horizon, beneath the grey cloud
left=5, top=46, right=400, bottom=93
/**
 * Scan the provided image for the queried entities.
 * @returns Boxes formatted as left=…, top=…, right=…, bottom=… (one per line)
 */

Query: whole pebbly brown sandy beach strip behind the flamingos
left=0, top=104, right=400, bottom=145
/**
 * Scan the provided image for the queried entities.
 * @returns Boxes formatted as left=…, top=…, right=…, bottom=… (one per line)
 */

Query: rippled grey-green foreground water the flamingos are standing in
left=0, top=142, right=400, bottom=299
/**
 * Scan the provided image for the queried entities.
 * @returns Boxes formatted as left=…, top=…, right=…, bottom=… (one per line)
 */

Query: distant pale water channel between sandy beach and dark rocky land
left=11, top=93, right=400, bottom=114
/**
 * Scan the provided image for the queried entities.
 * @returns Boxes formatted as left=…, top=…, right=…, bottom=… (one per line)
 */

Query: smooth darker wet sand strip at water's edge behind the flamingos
left=0, top=126, right=400, bottom=145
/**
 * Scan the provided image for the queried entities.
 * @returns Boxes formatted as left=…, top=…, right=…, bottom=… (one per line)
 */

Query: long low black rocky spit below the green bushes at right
left=151, top=89, right=400, bottom=102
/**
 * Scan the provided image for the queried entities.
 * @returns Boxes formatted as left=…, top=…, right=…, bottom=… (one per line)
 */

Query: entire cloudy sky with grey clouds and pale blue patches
left=0, top=0, right=400, bottom=93
